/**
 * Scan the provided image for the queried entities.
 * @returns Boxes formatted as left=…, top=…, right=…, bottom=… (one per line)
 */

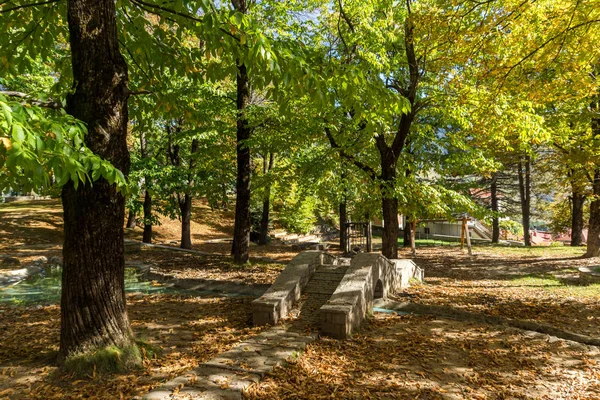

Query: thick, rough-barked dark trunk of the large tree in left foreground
left=59, top=0, right=134, bottom=361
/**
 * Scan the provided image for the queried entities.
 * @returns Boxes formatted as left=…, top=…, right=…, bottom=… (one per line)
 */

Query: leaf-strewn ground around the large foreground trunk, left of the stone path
left=0, top=294, right=263, bottom=400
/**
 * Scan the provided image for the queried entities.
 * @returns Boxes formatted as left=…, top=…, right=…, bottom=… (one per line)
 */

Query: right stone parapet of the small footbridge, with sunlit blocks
left=319, top=253, right=398, bottom=339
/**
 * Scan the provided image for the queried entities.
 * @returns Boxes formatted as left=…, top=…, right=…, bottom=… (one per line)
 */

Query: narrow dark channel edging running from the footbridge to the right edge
left=376, top=300, right=600, bottom=347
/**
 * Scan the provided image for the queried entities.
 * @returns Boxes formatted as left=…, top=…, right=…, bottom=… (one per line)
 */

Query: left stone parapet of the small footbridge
left=252, top=250, right=337, bottom=326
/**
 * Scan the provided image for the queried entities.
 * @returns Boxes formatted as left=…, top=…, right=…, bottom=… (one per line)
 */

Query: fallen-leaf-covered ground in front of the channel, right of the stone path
left=249, top=314, right=600, bottom=399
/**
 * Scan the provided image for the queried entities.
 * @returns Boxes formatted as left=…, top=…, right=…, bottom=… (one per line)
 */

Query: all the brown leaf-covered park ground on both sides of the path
left=0, top=201, right=600, bottom=399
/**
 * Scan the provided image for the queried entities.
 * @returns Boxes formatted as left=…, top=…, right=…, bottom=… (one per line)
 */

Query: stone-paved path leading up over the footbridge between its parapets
left=143, top=263, right=348, bottom=400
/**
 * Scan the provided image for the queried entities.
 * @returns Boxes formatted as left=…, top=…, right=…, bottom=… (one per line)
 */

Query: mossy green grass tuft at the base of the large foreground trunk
left=64, top=344, right=143, bottom=376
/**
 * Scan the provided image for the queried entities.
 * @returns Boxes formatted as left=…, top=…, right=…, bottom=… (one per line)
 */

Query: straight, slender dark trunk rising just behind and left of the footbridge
left=231, top=59, right=251, bottom=264
